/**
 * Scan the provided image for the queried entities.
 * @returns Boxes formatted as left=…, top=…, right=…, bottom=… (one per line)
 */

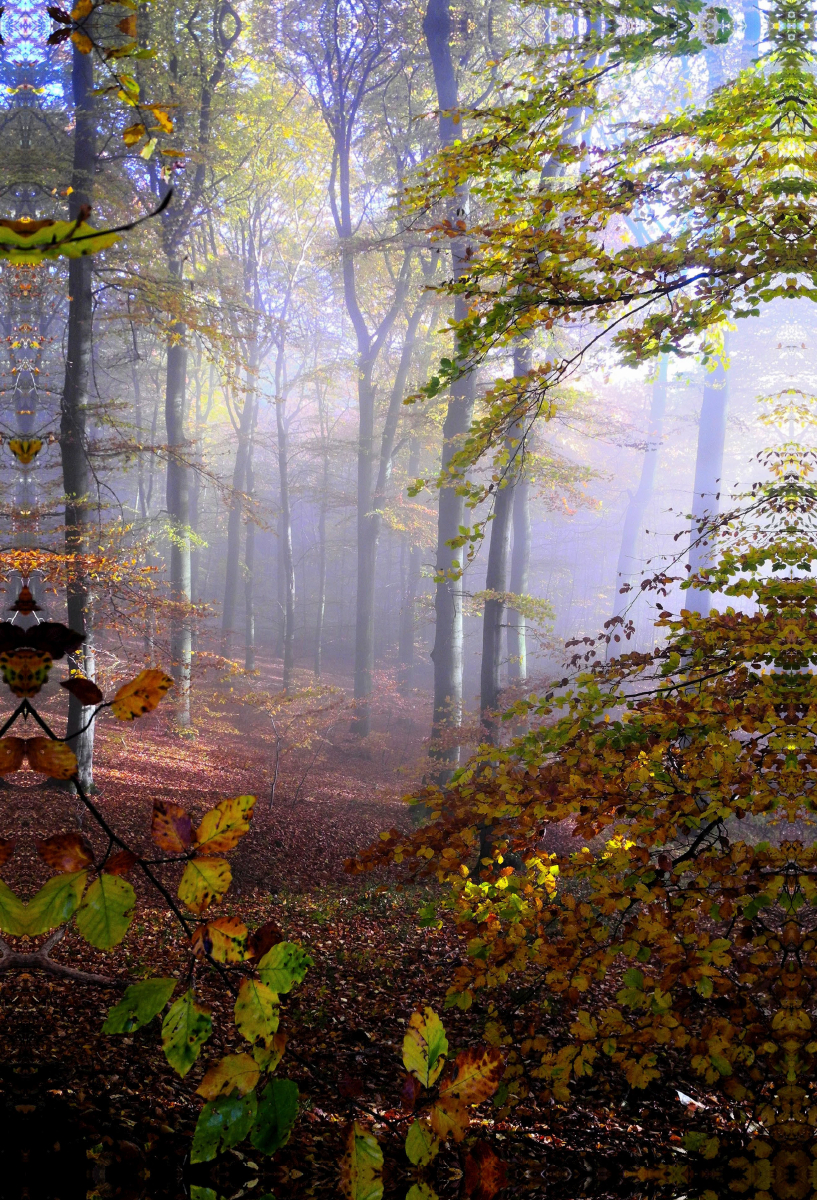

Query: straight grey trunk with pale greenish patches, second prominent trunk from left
left=164, top=259, right=192, bottom=726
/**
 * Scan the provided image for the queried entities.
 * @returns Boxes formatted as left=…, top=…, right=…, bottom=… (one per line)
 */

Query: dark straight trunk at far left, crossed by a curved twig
left=60, top=46, right=96, bottom=790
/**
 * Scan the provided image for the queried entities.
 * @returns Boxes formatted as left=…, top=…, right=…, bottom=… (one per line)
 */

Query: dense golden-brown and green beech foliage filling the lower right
left=352, top=445, right=817, bottom=1136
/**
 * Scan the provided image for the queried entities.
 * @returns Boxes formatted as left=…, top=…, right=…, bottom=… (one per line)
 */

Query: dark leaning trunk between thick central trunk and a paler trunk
left=480, top=466, right=515, bottom=745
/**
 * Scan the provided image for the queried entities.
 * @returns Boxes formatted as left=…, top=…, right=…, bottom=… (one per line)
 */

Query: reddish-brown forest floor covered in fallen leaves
left=0, top=681, right=715, bottom=1200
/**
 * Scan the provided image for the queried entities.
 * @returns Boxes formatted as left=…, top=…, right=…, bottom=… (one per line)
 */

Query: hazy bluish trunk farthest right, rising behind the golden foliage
left=686, top=335, right=729, bottom=616
